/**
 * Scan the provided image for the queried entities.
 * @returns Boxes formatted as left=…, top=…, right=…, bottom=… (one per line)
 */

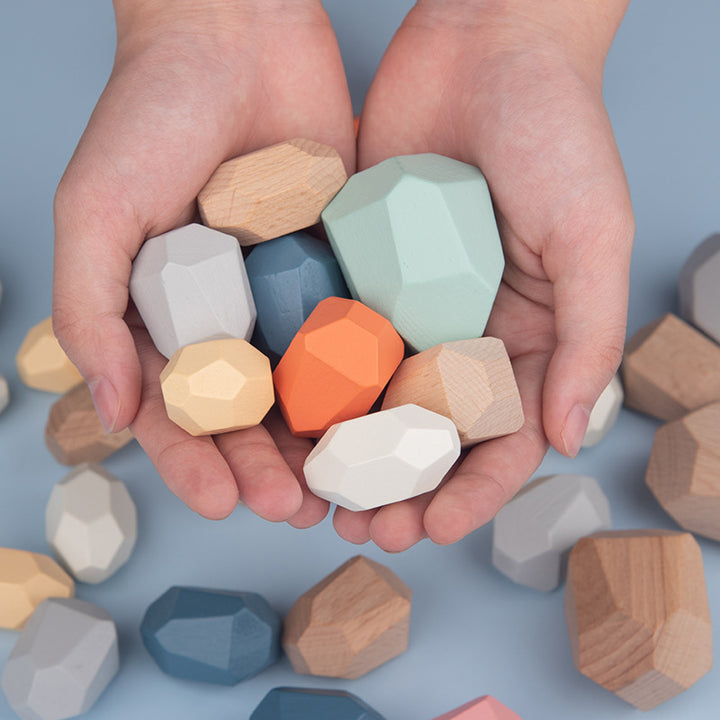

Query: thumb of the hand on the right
left=543, top=212, right=634, bottom=457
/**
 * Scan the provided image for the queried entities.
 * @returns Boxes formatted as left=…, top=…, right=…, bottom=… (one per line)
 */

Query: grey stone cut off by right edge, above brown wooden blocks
left=678, top=234, right=720, bottom=343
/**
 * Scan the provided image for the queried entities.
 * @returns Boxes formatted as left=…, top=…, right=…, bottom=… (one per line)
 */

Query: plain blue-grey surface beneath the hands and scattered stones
left=0, top=0, right=720, bottom=720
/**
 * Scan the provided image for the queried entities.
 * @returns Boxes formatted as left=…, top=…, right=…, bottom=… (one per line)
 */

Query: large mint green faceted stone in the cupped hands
left=322, top=154, right=505, bottom=351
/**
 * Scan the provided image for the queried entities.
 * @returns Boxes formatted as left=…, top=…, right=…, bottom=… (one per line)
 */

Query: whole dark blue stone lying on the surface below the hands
left=140, top=587, right=281, bottom=685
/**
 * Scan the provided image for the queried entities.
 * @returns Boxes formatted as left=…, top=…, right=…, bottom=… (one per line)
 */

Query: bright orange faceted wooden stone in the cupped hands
left=273, top=297, right=404, bottom=437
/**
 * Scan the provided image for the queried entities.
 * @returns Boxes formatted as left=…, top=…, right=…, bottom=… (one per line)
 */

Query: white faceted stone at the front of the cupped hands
left=304, top=405, right=460, bottom=510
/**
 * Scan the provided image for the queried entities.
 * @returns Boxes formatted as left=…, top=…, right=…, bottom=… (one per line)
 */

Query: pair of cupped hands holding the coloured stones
left=53, top=0, right=633, bottom=551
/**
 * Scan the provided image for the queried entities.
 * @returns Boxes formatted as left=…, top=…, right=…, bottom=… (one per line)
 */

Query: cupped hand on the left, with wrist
left=53, top=0, right=355, bottom=527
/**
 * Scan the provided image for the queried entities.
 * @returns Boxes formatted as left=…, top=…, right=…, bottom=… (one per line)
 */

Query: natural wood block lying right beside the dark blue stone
left=282, top=555, right=412, bottom=679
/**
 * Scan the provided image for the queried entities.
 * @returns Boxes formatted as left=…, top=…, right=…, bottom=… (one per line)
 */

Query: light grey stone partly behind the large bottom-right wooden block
left=492, top=475, right=611, bottom=592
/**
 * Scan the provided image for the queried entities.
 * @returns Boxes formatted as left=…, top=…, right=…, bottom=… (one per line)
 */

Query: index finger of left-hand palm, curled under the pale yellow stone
left=127, top=321, right=238, bottom=520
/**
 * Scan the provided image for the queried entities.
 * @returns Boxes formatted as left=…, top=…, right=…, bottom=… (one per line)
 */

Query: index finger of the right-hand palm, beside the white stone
left=423, top=352, right=548, bottom=545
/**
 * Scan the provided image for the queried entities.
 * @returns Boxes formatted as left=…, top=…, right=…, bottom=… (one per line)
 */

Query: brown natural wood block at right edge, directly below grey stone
left=622, top=314, right=720, bottom=420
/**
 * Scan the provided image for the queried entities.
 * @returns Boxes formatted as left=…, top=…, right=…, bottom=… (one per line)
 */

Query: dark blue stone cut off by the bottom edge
left=250, top=688, right=384, bottom=720
